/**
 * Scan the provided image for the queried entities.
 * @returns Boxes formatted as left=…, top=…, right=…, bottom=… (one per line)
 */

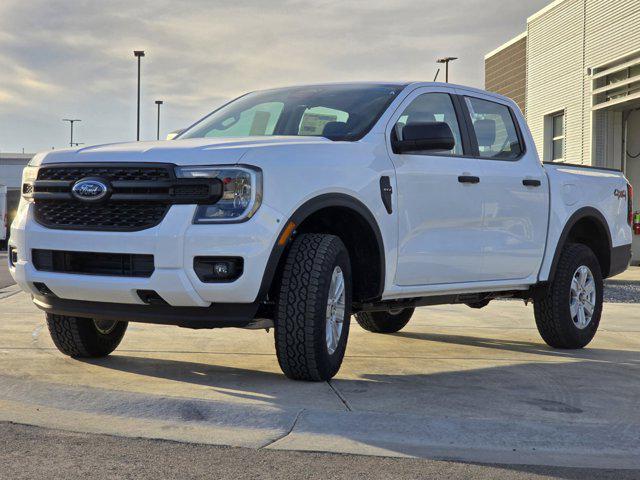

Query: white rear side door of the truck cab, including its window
left=458, top=91, right=549, bottom=281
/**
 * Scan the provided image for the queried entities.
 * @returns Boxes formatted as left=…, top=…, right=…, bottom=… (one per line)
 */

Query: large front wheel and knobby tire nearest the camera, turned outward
left=275, top=234, right=351, bottom=381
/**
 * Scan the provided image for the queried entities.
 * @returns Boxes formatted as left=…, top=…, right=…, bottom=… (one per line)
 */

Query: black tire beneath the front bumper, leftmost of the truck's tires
left=47, top=313, right=128, bottom=358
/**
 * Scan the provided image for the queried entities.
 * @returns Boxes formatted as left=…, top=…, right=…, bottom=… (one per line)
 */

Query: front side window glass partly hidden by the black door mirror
left=395, top=93, right=463, bottom=155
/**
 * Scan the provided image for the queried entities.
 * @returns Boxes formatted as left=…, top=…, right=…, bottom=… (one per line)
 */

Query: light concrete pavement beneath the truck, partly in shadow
left=0, top=289, right=640, bottom=468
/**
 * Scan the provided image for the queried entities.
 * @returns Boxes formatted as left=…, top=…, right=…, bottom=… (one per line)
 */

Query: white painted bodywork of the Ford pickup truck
left=11, top=83, right=631, bottom=306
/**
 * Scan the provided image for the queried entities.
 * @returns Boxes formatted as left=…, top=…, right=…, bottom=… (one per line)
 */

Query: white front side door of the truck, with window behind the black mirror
left=387, top=87, right=484, bottom=286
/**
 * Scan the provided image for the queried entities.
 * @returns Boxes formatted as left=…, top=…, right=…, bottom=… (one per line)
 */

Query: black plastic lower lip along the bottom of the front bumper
left=33, top=296, right=258, bottom=328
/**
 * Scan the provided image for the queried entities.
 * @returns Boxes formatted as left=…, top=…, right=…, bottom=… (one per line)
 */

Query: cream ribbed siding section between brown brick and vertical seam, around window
left=526, top=0, right=584, bottom=163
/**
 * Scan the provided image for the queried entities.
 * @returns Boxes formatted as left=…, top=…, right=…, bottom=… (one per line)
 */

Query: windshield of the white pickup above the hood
left=179, top=84, right=404, bottom=141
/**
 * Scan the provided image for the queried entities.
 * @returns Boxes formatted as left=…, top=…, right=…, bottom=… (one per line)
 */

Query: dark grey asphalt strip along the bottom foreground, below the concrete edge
left=0, top=423, right=640, bottom=480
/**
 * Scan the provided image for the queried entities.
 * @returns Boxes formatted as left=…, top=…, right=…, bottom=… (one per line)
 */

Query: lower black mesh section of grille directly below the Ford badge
left=35, top=200, right=170, bottom=231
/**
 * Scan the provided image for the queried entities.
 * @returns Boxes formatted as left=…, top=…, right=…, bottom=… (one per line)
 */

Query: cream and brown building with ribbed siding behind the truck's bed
left=485, top=0, right=640, bottom=264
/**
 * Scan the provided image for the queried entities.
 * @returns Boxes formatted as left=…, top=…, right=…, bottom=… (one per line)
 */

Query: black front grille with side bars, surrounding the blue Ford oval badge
left=27, top=163, right=222, bottom=231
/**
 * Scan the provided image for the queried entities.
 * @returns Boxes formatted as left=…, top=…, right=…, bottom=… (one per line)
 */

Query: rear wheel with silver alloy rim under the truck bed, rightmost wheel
left=533, top=244, right=603, bottom=349
